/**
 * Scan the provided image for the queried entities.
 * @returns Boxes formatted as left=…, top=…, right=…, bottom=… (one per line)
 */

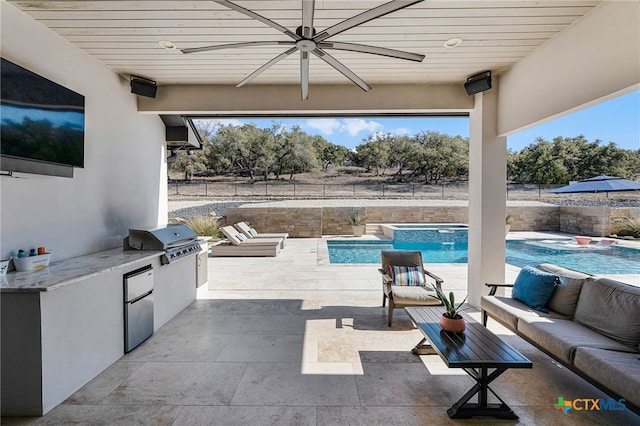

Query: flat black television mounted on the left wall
left=0, top=58, right=84, bottom=176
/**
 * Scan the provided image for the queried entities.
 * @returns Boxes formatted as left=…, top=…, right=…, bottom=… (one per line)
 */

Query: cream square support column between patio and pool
left=467, top=85, right=507, bottom=307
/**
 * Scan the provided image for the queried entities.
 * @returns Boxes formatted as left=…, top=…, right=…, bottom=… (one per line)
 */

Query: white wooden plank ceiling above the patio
left=10, top=0, right=600, bottom=85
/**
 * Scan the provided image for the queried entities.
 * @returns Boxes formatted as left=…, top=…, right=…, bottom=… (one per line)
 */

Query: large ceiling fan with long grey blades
left=181, top=0, right=424, bottom=100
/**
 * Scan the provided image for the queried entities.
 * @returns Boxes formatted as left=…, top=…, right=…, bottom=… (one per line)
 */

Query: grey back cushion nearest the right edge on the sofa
left=575, top=278, right=640, bottom=350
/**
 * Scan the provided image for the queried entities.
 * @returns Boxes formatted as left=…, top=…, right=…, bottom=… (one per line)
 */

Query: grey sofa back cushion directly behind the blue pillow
left=538, top=263, right=590, bottom=317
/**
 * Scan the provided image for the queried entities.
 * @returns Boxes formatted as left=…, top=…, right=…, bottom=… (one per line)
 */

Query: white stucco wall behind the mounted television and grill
left=0, top=1, right=167, bottom=260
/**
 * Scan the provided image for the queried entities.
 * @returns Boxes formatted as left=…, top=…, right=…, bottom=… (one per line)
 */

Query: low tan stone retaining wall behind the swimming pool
left=226, top=204, right=640, bottom=238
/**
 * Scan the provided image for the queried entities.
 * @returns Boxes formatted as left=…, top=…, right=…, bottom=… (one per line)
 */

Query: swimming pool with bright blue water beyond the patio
left=327, top=240, right=640, bottom=274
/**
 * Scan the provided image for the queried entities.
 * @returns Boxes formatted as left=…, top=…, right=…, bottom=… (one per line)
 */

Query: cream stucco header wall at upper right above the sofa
left=498, top=0, right=640, bottom=136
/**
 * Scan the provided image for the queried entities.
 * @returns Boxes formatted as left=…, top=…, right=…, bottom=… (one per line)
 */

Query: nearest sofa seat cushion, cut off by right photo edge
left=573, top=347, right=640, bottom=412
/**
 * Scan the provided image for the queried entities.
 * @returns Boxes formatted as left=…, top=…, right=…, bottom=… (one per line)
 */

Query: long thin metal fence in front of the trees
left=168, top=181, right=561, bottom=199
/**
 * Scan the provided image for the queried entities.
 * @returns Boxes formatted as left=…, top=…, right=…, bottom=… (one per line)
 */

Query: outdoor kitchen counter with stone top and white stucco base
left=0, top=248, right=198, bottom=416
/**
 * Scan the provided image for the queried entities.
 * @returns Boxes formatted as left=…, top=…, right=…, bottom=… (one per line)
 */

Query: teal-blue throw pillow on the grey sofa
left=511, top=266, right=560, bottom=313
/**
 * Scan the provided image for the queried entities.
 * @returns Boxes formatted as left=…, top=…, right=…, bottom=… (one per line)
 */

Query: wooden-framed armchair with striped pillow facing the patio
left=378, top=250, right=443, bottom=327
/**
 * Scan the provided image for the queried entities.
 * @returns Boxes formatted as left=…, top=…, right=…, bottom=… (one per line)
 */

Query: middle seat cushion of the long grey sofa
left=518, top=316, right=633, bottom=364
